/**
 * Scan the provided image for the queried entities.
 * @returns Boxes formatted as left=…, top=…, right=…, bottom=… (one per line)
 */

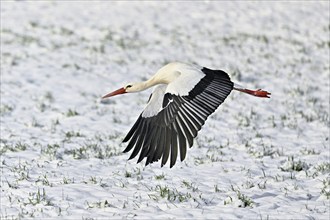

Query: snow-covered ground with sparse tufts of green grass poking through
left=0, top=1, right=330, bottom=219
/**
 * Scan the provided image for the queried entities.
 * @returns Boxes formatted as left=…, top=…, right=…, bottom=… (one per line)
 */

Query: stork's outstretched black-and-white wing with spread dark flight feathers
left=123, top=67, right=233, bottom=167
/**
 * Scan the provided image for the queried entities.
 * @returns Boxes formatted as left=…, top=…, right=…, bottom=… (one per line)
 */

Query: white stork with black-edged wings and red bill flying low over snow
left=102, top=62, right=270, bottom=167
